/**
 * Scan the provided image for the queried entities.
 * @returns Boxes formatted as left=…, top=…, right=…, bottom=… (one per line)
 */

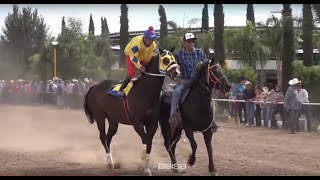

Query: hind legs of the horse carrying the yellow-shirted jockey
left=96, top=116, right=118, bottom=169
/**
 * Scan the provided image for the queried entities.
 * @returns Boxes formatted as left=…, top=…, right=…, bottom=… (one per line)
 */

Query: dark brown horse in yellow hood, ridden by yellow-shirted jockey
left=84, top=49, right=180, bottom=175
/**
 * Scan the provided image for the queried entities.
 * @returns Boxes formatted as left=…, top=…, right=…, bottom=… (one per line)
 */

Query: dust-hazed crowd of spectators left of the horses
left=0, top=77, right=97, bottom=109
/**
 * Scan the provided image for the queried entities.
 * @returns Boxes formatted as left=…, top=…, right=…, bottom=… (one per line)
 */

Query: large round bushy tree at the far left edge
left=1, top=5, right=48, bottom=78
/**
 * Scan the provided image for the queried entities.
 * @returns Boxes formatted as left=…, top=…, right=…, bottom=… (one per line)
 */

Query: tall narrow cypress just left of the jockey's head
left=119, top=4, right=129, bottom=68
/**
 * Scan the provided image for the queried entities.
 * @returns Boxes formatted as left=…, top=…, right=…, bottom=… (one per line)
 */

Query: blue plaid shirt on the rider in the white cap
left=174, top=48, right=208, bottom=80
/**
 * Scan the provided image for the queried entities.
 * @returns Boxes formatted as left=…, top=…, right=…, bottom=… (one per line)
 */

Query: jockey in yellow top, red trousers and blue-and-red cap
left=117, top=26, right=158, bottom=97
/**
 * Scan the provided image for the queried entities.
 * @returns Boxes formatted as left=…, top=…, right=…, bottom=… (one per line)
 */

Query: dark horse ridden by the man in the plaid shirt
left=160, top=60, right=230, bottom=175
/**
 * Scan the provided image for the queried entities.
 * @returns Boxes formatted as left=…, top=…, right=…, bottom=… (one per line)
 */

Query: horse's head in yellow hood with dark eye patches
left=147, top=47, right=180, bottom=80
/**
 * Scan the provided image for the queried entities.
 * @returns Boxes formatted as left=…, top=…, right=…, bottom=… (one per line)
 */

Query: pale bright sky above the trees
left=0, top=4, right=302, bottom=36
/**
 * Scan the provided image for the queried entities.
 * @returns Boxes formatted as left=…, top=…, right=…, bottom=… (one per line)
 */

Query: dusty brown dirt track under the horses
left=0, top=106, right=320, bottom=176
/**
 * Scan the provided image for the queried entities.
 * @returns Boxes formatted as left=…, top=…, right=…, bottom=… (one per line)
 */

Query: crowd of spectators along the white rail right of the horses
left=229, top=76, right=312, bottom=134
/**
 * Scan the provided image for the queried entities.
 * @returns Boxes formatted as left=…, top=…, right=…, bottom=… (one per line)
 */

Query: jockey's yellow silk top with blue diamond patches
left=124, top=35, right=157, bottom=69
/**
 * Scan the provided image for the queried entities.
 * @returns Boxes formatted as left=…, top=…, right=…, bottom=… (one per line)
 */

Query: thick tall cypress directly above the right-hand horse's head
left=213, top=4, right=225, bottom=65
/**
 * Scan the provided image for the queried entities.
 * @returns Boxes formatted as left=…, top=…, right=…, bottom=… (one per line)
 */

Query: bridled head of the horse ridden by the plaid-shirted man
left=206, top=58, right=231, bottom=94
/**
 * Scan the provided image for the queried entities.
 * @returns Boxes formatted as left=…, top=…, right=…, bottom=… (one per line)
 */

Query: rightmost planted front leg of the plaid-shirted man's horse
left=202, top=129, right=218, bottom=176
